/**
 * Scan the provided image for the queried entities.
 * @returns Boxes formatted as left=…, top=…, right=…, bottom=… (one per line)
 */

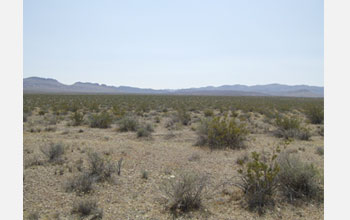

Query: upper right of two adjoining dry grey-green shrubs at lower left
left=88, top=152, right=117, bottom=182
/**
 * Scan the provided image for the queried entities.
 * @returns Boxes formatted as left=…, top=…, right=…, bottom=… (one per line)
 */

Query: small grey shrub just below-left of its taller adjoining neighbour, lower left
left=64, top=172, right=94, bottom=194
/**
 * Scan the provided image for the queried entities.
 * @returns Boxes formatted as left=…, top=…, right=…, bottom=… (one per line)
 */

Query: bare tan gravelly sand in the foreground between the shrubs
left=23, top=111, right=324, bottom=220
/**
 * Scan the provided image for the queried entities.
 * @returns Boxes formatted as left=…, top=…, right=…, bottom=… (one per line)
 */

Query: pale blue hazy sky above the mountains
left=23, top=0, right=324, bottom=89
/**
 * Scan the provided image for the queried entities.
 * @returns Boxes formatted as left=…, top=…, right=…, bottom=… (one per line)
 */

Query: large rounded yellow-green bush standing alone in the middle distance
left=197, top=117, right=248, bottom=149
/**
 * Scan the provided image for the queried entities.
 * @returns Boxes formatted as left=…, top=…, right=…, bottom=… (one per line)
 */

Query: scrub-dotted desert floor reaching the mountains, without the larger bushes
left=23, top=95, right=324, bottom=220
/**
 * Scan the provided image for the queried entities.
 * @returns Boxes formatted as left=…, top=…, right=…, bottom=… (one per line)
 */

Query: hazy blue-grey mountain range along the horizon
left=23, top=77, right=324, bottom=97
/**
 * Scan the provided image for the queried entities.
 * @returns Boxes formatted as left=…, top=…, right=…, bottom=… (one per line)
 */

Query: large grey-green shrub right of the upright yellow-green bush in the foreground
left=278, top=153, right=323, bottom=202
